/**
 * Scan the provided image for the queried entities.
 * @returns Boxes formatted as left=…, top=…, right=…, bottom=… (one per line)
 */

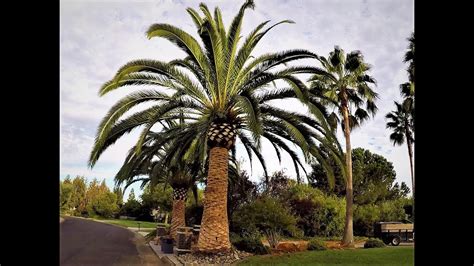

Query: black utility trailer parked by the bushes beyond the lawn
left=374, top=222, right=415, bottom=246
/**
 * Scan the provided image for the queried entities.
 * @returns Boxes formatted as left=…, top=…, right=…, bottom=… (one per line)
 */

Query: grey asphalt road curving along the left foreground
left=60, top=217, right=164, bottom=265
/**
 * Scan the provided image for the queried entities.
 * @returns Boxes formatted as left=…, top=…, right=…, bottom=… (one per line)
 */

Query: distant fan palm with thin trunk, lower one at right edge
left=385, top=102, right=415, bottom=216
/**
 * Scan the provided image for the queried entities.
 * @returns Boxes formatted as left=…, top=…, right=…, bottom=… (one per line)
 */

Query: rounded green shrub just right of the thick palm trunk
left=233, top=198, right=298, bottom=248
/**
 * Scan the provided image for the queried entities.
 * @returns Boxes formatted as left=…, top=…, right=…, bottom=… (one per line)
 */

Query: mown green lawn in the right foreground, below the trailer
left=239, top=247, right=414, bottom=265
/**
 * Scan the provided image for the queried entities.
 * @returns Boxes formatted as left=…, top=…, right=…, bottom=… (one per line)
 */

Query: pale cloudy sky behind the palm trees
left=60, top=0, right=414, bottom=198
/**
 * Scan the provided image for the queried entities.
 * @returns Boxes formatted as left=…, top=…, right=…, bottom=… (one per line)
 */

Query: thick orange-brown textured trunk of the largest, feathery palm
left=195, top=147, right=231, bottom=253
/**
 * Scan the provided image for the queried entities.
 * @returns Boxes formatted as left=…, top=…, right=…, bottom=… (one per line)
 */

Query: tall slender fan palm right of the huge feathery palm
left=310, top=46, right=377, bottom=246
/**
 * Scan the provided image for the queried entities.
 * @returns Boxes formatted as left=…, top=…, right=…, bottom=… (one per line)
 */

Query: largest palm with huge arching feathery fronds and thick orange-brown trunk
left=89, top=0, right=339, bottom=252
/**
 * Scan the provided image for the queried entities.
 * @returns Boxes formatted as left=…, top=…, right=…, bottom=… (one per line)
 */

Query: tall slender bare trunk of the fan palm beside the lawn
left=342, top=100, right=354, bottom=247
